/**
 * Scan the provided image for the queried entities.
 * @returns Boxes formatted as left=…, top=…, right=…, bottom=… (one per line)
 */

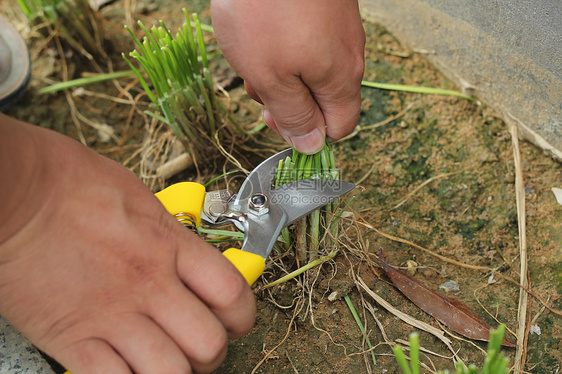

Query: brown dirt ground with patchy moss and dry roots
left=0, top=0, right=562, bottom=373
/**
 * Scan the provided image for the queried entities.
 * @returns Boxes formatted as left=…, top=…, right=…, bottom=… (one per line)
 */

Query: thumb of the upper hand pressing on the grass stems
left=252, top=78, right=326, bottom=154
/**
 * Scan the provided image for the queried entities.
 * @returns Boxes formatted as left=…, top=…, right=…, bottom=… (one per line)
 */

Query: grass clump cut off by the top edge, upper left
left=17, top=0, right=104, bottom=55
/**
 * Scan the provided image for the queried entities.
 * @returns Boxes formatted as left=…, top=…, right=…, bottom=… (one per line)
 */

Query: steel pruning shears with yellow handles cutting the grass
left=156, top=148, right=355, bottom=285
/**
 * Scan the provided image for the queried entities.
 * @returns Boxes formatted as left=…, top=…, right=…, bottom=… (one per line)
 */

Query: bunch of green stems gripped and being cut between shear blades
left=274, top=142, right=339, bottom=262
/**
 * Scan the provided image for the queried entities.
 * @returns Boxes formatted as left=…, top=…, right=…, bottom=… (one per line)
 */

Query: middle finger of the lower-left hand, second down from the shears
left=150, top=270, right=227, bottom=372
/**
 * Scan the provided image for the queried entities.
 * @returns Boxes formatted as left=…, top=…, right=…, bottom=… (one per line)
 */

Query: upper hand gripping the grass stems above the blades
left=211, top=0, right=365, bottom=154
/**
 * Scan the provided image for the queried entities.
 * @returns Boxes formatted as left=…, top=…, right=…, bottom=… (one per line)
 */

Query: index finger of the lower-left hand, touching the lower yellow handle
left=178, top=238, right=256, bottom=338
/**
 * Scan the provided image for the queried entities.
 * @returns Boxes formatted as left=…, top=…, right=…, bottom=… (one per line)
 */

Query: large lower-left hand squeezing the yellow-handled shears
left=0, top=115, right=255, bottom=374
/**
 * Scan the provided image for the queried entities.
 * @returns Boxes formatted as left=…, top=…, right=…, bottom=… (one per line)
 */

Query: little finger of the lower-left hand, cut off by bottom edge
left=53, top=339, right=131, bottom=374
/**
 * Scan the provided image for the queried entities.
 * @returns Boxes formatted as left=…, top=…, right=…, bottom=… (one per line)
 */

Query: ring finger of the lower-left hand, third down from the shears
left=105, top=314, right=191, bottom=374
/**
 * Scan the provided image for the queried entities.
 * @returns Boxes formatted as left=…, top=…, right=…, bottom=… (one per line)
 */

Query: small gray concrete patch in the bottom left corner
left=0, top=316, right=54, bottom=374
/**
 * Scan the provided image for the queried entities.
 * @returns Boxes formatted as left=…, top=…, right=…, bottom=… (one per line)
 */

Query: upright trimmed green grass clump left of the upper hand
left=123, top=9, right=228, bottom=159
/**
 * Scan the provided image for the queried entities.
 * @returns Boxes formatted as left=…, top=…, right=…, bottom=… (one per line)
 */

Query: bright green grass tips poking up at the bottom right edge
left=393, top=325, right=509, bottom=374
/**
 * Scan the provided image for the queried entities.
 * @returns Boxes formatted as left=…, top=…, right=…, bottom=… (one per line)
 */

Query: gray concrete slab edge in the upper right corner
left=360, top=0, right=562, bottom=161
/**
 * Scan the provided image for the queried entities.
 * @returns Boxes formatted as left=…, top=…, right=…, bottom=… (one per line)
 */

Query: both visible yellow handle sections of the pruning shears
left=156, top=182, right=265, bottom=286
